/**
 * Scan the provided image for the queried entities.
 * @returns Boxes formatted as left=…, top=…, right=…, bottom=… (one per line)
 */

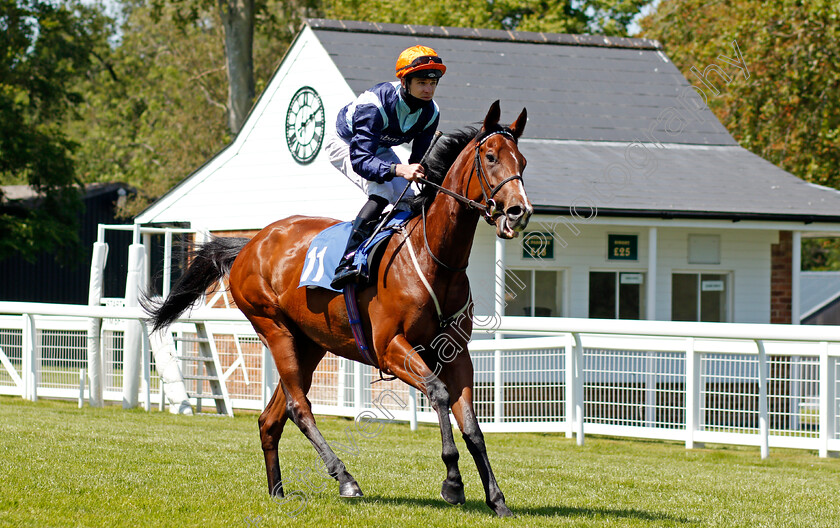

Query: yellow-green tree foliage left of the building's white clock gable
left=66, top=1, right=297, bottom=215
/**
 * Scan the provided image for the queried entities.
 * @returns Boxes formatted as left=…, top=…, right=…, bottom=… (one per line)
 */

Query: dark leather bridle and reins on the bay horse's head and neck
left=406, top=128, right=522, bottom=272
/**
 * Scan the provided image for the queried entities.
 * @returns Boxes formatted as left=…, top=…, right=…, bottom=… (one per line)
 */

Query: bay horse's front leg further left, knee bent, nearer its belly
left=383, top=335, right=466, bottom=504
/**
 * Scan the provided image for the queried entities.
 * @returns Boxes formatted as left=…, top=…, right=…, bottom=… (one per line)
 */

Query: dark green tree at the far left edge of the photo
left=0, top=0, right=110, bottom=260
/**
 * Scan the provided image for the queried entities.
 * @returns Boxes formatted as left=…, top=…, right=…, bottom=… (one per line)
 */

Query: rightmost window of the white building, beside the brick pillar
left=671, top=273, right=729, bottom=323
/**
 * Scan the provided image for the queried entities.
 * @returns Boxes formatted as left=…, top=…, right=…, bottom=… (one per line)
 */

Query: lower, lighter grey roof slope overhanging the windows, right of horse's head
left=521, top=139, right=840, bottom=222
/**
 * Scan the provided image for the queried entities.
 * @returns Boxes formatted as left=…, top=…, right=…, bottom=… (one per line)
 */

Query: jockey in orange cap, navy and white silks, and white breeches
left=326, top=46, right=446, bottom=290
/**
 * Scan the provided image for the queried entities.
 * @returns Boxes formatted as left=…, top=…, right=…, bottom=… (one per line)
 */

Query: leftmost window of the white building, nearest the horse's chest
left=505, top=270, right=563, bottom=317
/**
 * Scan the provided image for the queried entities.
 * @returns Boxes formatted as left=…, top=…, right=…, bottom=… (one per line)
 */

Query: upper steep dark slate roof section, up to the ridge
left=308, top=19, right=737, bottom=145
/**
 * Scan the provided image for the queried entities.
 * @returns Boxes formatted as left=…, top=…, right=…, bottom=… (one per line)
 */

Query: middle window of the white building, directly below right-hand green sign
left=589, top=271, right=645, bottom=319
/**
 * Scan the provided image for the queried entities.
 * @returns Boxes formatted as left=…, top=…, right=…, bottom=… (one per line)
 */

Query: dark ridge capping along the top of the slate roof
left=304, top=18, right=662, bottom=51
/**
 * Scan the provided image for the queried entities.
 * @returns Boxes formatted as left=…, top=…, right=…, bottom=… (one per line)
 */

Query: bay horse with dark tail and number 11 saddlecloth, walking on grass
left=141, top=101, right=533, bottom=516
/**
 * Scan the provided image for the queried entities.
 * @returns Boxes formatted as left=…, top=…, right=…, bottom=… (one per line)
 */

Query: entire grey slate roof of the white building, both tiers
left=307, top=19, right=840, bottom=222
